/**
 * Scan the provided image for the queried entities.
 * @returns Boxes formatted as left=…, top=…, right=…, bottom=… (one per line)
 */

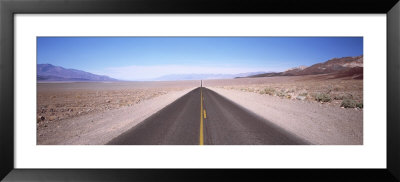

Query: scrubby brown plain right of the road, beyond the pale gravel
left=203, top=75, right=363, bottom=109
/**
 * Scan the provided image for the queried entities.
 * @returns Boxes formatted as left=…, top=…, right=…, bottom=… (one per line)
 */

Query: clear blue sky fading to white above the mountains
left=37, top=37, right=363, bottom=80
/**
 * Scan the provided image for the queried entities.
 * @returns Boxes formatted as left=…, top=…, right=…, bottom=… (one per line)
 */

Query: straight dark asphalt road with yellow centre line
left=108, top=87, right=307, bottom=145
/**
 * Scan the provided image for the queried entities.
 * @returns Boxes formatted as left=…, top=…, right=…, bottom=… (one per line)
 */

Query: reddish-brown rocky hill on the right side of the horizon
left=250, top=55, right=363, bottom=79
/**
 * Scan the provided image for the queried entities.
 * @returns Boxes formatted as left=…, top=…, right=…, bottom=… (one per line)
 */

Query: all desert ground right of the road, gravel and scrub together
left=204, top=75, right=363, bottom=145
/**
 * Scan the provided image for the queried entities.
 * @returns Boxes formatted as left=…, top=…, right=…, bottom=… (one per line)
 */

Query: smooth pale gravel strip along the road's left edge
left=37, top=88, right=194, bottom=145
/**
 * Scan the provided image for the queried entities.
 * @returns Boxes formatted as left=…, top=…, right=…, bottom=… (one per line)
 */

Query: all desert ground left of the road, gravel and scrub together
left=37, top=81, right=198, bottom=145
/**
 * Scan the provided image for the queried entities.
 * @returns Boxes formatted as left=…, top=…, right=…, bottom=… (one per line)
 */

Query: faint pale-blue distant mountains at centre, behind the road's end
left=154, top=71, right=265, bottom=81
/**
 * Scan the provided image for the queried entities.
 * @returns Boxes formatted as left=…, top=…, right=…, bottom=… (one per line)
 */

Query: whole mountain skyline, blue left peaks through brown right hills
left=37, top=55, right=363, bottom=81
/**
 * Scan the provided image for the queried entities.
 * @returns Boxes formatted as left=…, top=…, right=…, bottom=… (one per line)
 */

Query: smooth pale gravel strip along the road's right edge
left=207, top=87, right=363, bottom=145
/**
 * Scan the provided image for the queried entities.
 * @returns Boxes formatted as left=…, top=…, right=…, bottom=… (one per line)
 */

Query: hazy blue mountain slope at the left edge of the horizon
left=37, top=64, right=117, bottom=81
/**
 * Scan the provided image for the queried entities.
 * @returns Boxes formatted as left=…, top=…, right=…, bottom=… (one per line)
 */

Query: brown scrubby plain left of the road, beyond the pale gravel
left=37, top=81, right=200, bottom=124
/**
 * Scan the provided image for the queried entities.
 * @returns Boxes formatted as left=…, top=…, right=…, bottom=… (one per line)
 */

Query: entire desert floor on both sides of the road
left=37, top=75, right=363, bottom=145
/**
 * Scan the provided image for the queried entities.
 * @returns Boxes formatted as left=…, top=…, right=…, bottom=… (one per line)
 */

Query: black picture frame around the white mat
left=0, top=0, right=400, bottom=181
